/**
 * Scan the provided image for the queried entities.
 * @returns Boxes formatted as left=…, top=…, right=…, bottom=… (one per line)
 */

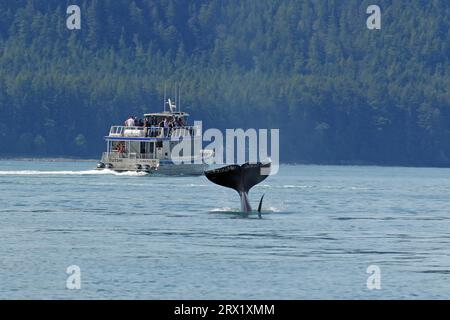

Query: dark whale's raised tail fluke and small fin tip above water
left=205, top=162, right=270, bottom=212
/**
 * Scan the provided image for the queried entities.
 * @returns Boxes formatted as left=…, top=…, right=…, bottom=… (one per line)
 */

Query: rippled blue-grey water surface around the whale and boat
left=0, top=161, right=450, bottom=299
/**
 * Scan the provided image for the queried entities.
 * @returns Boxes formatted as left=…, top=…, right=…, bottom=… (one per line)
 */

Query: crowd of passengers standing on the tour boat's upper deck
left=124, top=116, right=184, bottom=137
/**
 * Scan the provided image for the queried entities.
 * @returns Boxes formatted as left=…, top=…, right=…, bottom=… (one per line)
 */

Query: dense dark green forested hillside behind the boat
left=0, top=0, right=450, bottom=165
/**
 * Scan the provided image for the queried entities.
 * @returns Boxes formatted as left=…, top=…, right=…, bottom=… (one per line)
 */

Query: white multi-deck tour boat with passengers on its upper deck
left=97, top=99, right=214, bottom=175
